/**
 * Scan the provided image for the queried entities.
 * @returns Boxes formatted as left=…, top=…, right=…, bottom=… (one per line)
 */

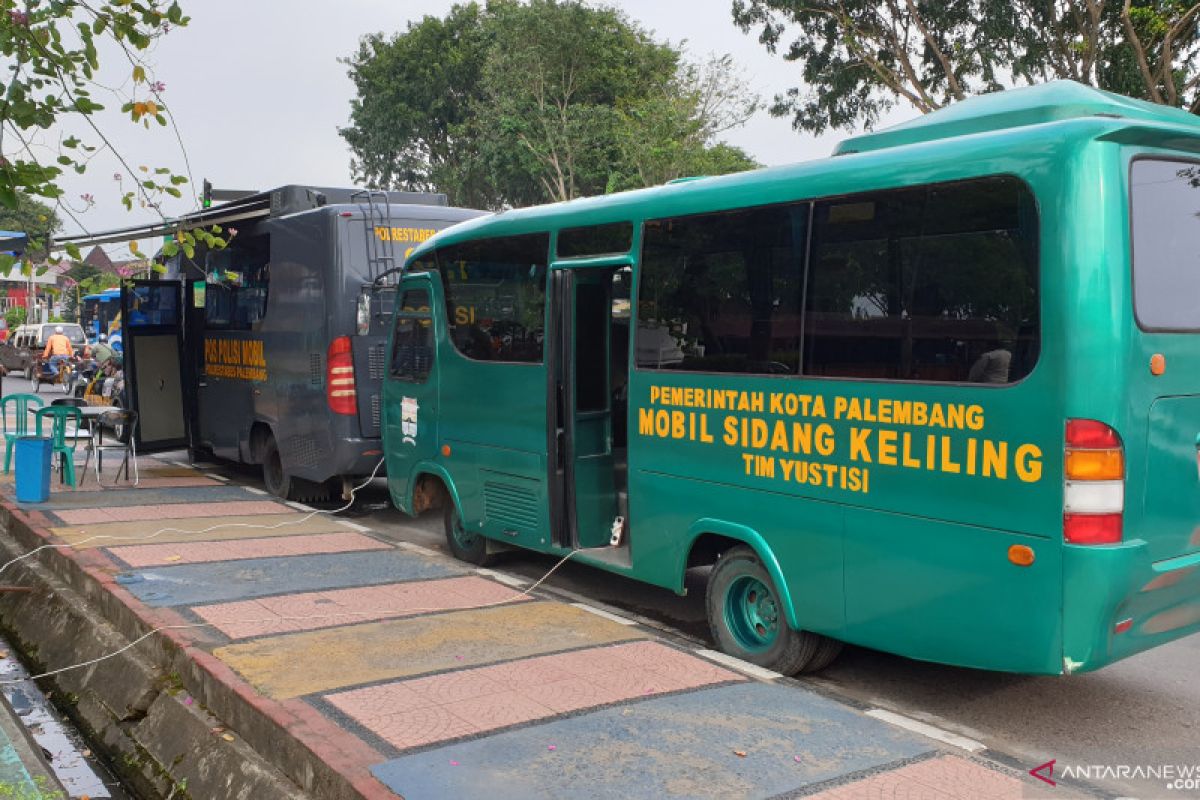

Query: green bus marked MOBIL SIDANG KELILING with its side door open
left=384, top=82, right=1200, bottom=674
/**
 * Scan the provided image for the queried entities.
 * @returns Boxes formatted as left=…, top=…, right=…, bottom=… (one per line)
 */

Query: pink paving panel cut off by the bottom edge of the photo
left=810, top=756, right=1024, bottom=800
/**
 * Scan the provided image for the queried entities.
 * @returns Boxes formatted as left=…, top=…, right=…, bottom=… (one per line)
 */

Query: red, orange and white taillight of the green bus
left=1062, top=420, right=1124, bottom=545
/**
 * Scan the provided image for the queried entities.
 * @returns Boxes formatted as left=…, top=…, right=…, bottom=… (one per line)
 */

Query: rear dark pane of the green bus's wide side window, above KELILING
left=804, top=176, right=1039, bottom=384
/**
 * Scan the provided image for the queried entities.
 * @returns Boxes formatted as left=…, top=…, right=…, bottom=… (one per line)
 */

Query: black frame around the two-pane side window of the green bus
left=630, top=172, right=1045, bottom=391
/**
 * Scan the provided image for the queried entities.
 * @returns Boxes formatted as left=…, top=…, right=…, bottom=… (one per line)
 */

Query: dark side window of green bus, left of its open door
left=437, top=234, right=550, bottom=363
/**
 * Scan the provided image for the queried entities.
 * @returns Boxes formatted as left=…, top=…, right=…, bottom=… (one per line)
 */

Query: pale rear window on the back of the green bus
left=1129, top=158, right=1200, bottom=330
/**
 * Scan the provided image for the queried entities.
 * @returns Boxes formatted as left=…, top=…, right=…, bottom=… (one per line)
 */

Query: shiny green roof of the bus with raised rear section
left=410, top=80, right=1200, bottom=260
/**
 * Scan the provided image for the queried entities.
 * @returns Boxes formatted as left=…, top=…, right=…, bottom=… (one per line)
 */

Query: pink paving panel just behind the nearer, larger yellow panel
left=193, top=575, right=529, bottom=639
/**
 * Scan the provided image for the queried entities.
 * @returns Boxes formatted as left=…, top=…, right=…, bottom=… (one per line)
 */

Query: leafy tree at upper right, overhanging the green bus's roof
left=733, top=0, right=1200, bottom=133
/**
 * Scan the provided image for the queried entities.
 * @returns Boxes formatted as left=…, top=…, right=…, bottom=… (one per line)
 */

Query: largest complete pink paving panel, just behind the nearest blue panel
left=325, top=642, right=744, bottom=750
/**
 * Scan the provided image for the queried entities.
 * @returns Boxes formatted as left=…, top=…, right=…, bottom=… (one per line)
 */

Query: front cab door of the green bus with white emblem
left=382, top=275, right=438, bottom=512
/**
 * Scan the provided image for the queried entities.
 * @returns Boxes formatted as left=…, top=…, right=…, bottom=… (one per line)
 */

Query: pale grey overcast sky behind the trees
left=44, top=0, right=913, bottom=250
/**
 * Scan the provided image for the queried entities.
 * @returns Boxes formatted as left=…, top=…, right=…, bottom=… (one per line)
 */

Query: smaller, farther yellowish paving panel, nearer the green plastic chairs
left=50, top=506, right=350, bottom=549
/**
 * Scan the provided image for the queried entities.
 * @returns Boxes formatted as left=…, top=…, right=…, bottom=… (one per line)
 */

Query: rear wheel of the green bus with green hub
left=704, top=546, right=841, bottom=675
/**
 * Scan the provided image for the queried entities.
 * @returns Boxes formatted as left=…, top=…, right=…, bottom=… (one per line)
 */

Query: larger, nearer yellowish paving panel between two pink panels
left=214, top=602, right=646, bottom=698
